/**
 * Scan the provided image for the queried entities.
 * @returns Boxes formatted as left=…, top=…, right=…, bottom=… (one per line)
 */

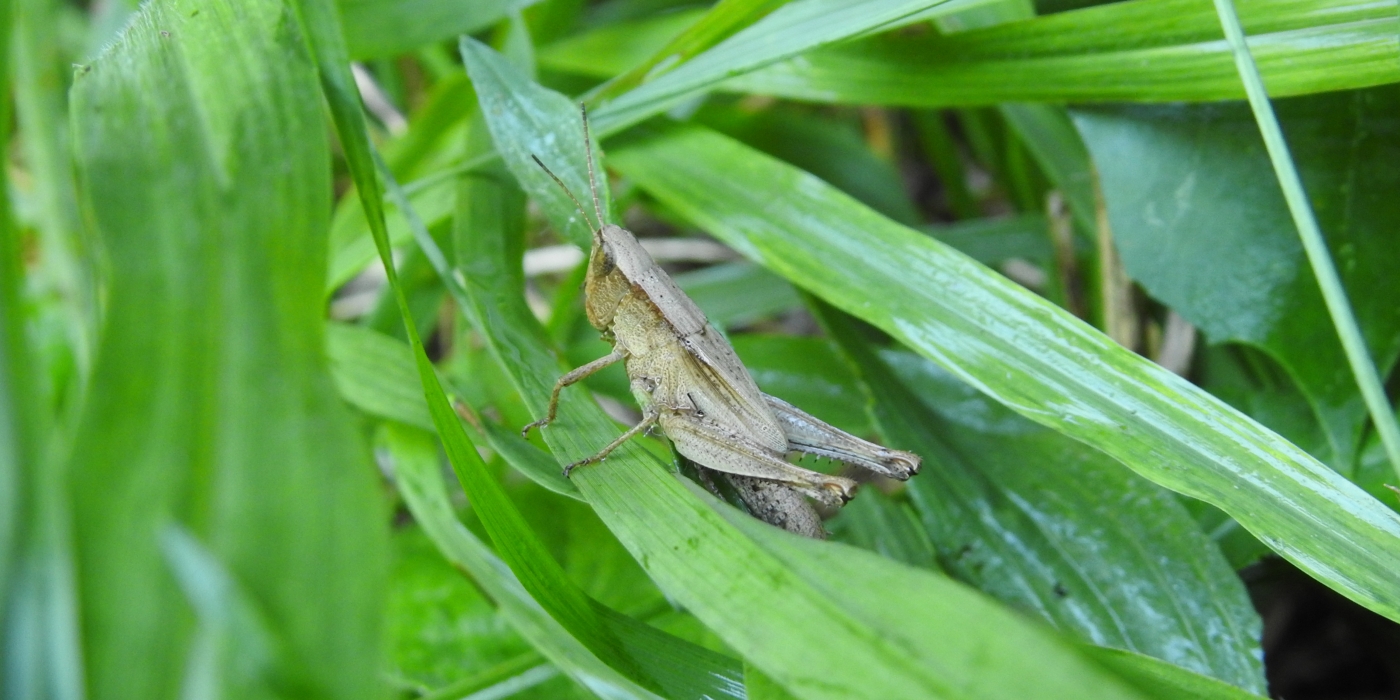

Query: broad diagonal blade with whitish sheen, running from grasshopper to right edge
left=610, top=129, right=1400, bottom=619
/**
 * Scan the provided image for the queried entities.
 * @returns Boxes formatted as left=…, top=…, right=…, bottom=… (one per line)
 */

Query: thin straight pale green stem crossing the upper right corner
left=1215, top=0, right=1400, bottom=476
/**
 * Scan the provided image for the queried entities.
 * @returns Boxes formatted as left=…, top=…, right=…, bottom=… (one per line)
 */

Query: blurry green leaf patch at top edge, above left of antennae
left=336, top=0, right=539, bottom=59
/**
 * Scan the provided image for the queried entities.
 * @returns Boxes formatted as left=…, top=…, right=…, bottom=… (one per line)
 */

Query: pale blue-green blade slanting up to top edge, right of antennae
left=585, top=0, right=946, bottom=134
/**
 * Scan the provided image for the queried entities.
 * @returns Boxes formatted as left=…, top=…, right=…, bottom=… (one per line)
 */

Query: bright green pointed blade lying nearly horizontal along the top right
left=721, top=0, right=1400, bottom=106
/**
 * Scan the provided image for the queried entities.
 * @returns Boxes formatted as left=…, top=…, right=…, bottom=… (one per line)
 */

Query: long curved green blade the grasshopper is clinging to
left=456, top=39, right=1159, bottom=697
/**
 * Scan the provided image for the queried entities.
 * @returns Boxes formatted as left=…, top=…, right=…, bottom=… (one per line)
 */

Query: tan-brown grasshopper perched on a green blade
left=521, top=113, right=921, bottom=535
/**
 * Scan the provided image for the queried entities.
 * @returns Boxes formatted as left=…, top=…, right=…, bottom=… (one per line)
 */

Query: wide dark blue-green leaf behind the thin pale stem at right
left=1075, top=87, right=1400, bottom=476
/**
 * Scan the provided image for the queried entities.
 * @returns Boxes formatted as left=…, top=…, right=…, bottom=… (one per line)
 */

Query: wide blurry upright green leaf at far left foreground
left=69, top=1, right=386, bottom=699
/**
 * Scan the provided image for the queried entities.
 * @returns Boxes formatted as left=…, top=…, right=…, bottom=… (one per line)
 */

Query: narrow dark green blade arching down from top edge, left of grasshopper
left=306, top=0, right=739, bottom=696
